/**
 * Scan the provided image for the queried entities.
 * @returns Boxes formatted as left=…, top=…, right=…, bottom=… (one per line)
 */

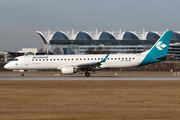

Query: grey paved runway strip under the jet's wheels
left=0, top=74, right=180, bottom=81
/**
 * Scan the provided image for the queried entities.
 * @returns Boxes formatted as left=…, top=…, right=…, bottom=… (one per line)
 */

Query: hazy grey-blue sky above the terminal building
left=0, top=0, right=180, bottom=51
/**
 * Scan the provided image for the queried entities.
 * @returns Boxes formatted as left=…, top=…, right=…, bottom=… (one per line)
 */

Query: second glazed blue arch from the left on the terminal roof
left=75, top=31, right=92, bottom=40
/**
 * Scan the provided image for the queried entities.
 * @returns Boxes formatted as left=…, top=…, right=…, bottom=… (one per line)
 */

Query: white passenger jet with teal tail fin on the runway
left=4, top=31, right=172, bottom=77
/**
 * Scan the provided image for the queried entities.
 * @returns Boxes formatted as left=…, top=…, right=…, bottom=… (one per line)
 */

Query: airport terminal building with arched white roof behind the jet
left=36, top=29, right=180, bottom=60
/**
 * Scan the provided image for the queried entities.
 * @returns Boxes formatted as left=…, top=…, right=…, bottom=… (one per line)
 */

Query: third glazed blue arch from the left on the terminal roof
left=99, top=31, right=116, bottom=40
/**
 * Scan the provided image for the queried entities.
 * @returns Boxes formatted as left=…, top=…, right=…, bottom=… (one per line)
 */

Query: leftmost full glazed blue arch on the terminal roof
left=52, top=32, right=69, bottom=40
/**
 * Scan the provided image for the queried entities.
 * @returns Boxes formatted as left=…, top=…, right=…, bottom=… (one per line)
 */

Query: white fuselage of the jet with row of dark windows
left=5, top=54, right=144, bottom=70
